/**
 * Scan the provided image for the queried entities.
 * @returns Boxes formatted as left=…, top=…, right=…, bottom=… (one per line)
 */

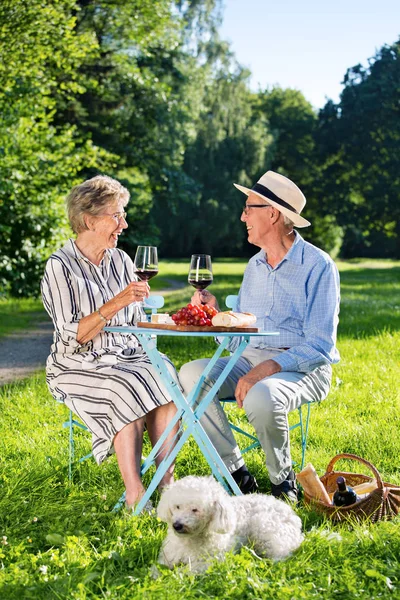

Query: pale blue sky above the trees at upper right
left=219, top=0, right=400, bottom=109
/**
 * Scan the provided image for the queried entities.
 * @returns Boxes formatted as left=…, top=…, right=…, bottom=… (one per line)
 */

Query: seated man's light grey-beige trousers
left=179, top=347, right=332, bottom=484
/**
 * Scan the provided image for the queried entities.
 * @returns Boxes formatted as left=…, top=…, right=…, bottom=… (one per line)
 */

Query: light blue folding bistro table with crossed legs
left=104, top=326, right=278, bottom=515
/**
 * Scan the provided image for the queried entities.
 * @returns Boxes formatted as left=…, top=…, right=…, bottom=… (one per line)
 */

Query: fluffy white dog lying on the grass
left=157, top=476, right=303, bottom=572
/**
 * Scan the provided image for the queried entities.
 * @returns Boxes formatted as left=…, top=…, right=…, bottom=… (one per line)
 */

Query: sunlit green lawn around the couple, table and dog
left=0, top=261, right=400, bottom=600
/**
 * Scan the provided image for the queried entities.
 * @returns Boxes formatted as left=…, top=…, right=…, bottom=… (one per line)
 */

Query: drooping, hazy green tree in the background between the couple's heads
left=155, top=61, right=271, bottom=256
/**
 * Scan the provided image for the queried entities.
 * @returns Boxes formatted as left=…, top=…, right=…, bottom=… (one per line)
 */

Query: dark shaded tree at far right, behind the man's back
left=316, top=41, right=400, bottom=257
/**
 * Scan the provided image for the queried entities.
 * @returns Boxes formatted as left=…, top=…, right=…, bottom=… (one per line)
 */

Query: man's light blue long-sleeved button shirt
left=237, top=232, right=340, bottom=373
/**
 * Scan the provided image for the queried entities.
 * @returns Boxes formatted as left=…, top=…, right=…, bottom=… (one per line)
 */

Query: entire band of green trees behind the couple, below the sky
left=0, top=0, right=400, bottom=296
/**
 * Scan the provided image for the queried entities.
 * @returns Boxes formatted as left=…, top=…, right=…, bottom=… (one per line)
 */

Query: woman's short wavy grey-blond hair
left=66, top=175, right=129, bottom=233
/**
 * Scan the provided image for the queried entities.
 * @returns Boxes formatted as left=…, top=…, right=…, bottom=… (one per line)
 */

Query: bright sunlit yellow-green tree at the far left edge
left=0, top=0, right=110, bottom=295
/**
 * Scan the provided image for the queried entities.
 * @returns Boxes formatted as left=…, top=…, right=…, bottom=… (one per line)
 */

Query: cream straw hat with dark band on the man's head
left=233, top=171, right=311, bottom=227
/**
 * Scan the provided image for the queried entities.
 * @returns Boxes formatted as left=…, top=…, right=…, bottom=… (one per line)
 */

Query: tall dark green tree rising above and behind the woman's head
left=56, top=0, right=223, bottom=253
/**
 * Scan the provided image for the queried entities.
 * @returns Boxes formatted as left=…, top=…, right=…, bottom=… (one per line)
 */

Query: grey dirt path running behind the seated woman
left=0, top=279, right=185, bottom=386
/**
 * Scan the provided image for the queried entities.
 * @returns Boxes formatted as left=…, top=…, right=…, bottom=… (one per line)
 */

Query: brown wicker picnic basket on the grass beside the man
left=304, top=454, right=400, bottom=522
